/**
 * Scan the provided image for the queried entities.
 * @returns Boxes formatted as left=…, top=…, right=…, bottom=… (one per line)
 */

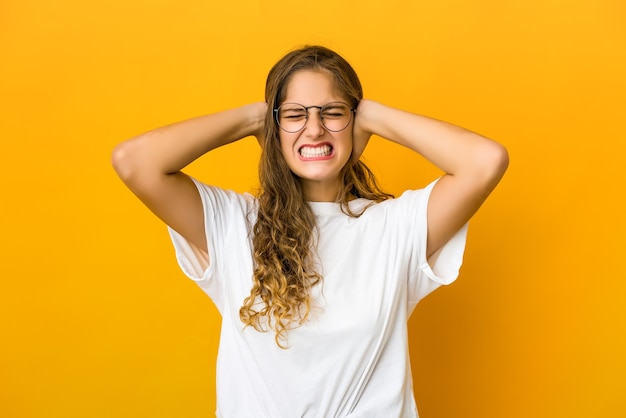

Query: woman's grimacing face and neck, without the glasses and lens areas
left=279, top=70, right=354, bottom=202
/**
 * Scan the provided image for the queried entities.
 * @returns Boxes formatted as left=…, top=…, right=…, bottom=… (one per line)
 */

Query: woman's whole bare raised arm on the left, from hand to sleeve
left=112, top=102, right=267, bottom=267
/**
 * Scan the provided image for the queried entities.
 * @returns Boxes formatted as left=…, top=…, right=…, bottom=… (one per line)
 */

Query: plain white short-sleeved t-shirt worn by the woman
left=170, top=181, right=467, bottom=418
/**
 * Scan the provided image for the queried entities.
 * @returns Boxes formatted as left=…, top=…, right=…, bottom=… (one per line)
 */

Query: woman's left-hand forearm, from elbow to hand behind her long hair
left=113, top=103, right=265, bottom=178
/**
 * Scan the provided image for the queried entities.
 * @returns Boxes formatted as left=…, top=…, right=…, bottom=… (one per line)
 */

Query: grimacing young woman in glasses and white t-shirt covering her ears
left=113, top=46, right=508, bottom=418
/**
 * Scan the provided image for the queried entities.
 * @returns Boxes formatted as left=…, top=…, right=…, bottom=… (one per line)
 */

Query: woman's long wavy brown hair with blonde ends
left=239, top=46, right=393, bottom=348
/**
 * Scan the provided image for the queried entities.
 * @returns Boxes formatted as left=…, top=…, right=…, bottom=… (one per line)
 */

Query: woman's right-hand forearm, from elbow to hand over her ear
left=359, top=100, right=506, bottom=180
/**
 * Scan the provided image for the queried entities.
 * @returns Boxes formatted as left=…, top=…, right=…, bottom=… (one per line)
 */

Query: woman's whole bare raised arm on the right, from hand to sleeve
left=354, top=100, right=509, bottom=256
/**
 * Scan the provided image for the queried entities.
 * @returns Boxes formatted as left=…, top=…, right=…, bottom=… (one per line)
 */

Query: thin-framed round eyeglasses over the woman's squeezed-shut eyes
left=274, top=102, right=356, bottom=133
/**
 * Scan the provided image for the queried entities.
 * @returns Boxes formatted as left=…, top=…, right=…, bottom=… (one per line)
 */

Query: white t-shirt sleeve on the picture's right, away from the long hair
left=399, top=180, right=468, bottom=310
